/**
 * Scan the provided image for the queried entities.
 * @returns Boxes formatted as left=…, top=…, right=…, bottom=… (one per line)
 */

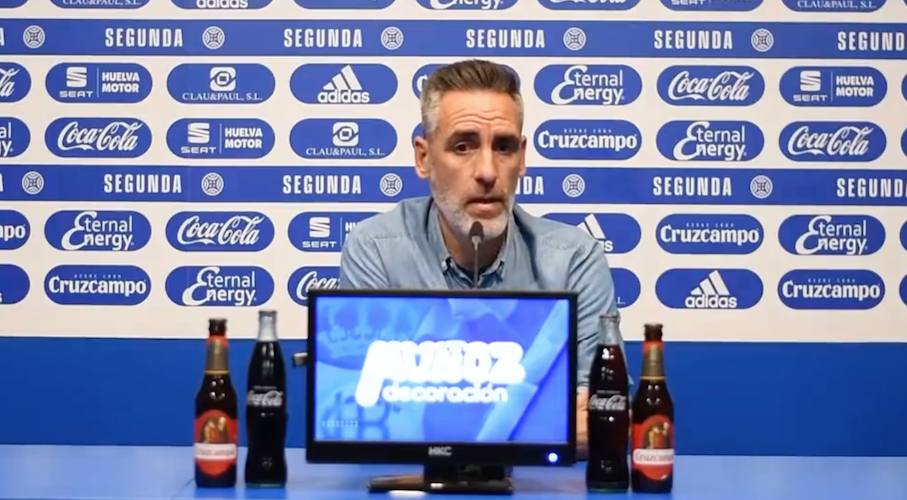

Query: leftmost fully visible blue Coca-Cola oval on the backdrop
left=45, top=118, right=151, bottom=158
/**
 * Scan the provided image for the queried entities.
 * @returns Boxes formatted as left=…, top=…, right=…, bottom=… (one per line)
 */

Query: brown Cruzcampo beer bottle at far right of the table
left=630, top=323, right=674, bottom=493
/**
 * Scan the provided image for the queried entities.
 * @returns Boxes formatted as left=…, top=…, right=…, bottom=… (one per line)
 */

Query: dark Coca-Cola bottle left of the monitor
left=245, top=311, right=287, bottom=487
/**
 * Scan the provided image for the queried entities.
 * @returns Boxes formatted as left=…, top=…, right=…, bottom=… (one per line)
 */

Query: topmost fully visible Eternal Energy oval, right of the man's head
left=535, top=64, right=642, bottom=106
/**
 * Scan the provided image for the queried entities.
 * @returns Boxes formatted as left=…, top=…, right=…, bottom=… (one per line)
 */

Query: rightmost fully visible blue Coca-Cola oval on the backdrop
left=780, top=122, right=886, bottom=161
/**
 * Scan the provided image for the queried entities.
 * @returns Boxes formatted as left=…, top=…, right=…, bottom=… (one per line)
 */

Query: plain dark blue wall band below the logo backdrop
left=0, top=338, right=907, bottom=455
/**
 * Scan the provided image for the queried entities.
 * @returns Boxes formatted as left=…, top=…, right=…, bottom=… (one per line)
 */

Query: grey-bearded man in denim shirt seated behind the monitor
left=340, top=60, right=617, bottom=456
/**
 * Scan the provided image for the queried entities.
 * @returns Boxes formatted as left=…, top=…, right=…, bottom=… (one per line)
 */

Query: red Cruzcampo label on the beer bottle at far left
left=195, top=410, right=237, bottom=476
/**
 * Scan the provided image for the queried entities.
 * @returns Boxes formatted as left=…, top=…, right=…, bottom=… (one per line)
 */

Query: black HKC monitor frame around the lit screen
left=306, top=289, right=577, bottom=466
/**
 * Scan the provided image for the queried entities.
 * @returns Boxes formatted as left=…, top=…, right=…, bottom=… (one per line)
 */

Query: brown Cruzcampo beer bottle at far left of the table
left=194, top=319, right=237, bottom=487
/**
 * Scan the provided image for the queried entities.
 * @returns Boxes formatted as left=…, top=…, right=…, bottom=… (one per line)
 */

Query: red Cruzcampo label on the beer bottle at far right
left=632, top=415, right=674, bottom=481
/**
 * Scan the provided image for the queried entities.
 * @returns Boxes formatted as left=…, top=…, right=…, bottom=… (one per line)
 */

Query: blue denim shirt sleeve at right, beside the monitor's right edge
left=568, top=244, right=633, bottom=387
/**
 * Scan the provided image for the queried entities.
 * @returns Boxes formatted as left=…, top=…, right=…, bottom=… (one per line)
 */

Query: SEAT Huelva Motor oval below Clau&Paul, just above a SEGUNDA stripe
left=167, top=118, right=274, bottom=159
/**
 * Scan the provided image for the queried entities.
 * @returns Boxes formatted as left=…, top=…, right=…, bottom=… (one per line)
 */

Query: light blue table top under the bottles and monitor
left=0, top=445, right=907, bottom=500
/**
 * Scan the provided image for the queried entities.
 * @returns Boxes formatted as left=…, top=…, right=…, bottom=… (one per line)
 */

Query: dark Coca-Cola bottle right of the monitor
left=586, top=313, right=630, bottom=491
